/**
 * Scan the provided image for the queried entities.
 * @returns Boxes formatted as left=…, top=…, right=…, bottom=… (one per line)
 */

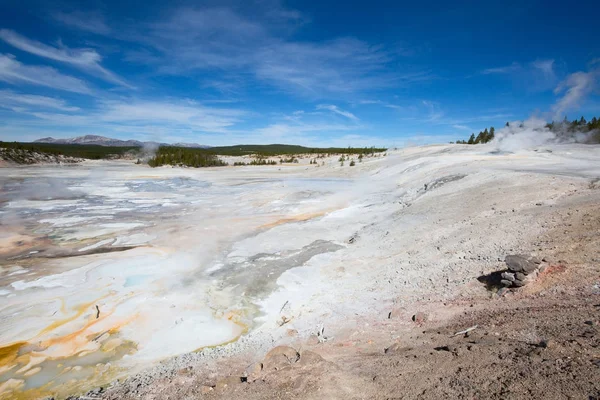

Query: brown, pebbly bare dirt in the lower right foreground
left=96, top=182, right=600, bottom=400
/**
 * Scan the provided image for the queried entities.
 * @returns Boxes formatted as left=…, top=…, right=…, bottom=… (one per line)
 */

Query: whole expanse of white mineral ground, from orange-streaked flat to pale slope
left=0, top=145, right=600, bottom=399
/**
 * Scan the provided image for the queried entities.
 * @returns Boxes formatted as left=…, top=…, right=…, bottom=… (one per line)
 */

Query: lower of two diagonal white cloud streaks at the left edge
left=0, top=54, right=92, bottom=94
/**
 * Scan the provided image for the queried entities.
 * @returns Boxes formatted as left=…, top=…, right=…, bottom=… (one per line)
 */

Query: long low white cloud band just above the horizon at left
left=0, top=96, right=386, bottom=147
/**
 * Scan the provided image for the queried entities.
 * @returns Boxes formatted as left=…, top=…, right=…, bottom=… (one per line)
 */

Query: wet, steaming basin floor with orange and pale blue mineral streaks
left=0, top=159, right=349, bottom=397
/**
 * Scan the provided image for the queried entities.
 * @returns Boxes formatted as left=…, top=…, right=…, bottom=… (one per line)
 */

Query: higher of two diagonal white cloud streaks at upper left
left=0, top=29, right=132, bottom=88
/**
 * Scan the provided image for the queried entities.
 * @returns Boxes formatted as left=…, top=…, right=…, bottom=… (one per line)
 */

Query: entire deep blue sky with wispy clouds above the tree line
left=0, top=0, right=600, bottom=146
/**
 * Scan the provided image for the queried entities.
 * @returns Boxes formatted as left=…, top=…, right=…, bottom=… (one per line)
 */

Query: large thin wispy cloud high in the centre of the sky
left=127, top=7, right=422, bottom=98
